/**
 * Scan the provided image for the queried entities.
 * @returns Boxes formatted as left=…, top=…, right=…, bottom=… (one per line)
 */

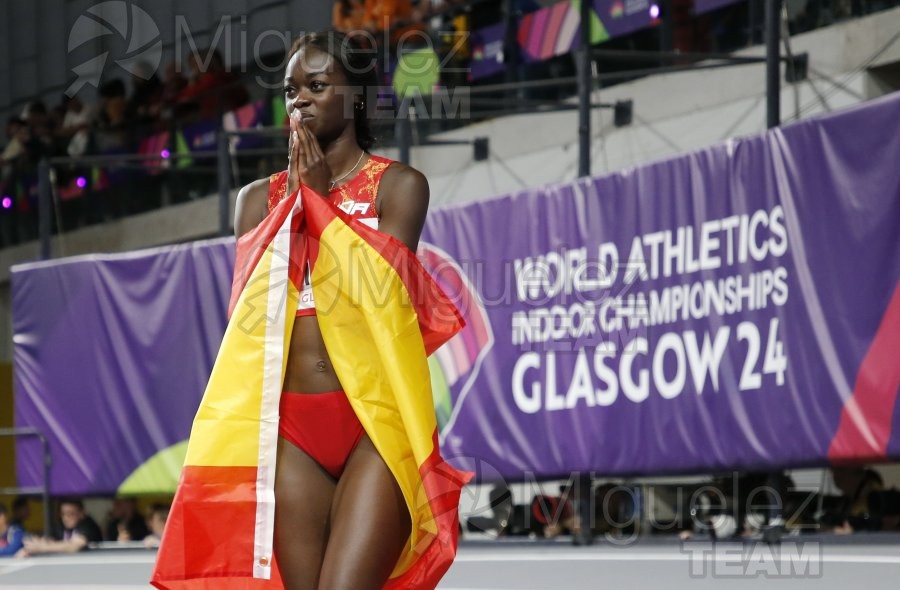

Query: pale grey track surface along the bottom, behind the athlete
left=0, top=537, right=900, bottom=590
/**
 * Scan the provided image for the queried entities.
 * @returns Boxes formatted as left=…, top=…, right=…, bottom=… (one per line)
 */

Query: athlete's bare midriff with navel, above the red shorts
left=283, top=315, right=341, bottom=393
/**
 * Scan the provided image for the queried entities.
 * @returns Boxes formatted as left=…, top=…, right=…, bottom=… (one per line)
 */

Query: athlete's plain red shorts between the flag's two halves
left=278, top=390, right=365, bottom=479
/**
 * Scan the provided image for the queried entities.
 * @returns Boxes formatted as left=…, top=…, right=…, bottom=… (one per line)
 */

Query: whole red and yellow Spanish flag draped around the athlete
left=151, top=186, right=470, bottom=590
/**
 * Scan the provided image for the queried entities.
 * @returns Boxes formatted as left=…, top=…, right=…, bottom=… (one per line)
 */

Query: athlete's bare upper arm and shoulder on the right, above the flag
left=376, top=162, right=429, bottom=252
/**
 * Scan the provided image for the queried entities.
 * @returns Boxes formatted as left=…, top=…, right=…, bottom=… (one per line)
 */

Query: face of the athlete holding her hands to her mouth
left=284, top=47, right=354, bottom=142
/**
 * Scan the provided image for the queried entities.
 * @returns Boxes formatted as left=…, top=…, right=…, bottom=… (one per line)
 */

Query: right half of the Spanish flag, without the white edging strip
left=303, top=186, right=468, bottom=588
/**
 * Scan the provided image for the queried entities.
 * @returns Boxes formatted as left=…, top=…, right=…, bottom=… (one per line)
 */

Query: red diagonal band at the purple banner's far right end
left=828, top=283, right=900, bottom=463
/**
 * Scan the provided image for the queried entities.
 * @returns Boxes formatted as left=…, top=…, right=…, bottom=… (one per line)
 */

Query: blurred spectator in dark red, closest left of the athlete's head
left=177, top=49, right=248, bottom=119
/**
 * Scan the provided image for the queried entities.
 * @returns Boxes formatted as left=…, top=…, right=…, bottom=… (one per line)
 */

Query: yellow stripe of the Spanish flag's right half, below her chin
left=311, top=218, right=437, bottom=577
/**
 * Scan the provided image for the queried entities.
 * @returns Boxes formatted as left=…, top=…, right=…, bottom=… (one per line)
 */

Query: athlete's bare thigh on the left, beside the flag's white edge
left=275, top=437, right=335, bottom=590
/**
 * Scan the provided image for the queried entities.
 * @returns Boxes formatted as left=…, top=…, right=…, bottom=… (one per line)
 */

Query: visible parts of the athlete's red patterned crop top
left=268, top=155, right=394, bottom=316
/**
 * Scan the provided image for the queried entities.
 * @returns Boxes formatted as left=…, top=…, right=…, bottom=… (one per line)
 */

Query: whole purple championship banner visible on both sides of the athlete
left=13, top=94, right=900, bottom=494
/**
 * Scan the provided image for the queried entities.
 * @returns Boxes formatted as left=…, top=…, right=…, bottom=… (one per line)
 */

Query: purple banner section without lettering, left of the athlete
left=12, top=239, right=234, bottom=494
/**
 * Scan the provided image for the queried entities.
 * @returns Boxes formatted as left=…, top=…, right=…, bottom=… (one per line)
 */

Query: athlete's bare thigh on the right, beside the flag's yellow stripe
left=320, top=435, right=410, bottom=590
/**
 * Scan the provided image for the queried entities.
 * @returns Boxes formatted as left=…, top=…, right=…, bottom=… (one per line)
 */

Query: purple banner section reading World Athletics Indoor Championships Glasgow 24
left=423, top=94, right=900, bottom=478
